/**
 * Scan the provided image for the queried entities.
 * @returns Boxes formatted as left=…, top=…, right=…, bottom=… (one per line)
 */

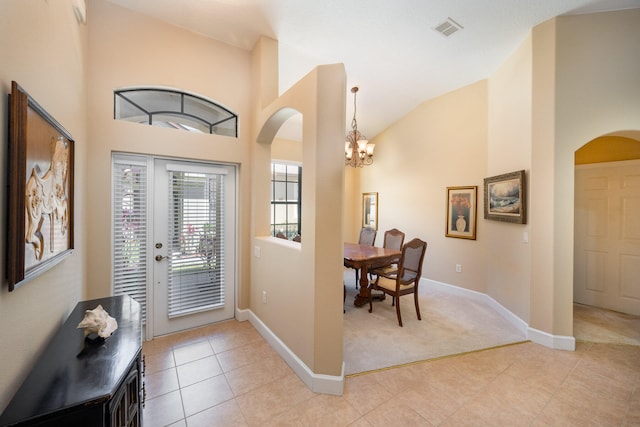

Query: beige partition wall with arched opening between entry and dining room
left=250, top=58, right=346, bottom=377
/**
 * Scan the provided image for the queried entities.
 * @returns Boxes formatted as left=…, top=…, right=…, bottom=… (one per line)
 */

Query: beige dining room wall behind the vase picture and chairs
left=356, top=80, right=488, bottom=293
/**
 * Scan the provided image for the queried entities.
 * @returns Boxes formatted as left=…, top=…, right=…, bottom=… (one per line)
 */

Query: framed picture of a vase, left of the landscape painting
left=445, top=186, right=478, bottom=240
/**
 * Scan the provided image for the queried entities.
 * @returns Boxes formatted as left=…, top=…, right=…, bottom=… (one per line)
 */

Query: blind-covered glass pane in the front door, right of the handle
left=167, top=165, right=226, bottom=318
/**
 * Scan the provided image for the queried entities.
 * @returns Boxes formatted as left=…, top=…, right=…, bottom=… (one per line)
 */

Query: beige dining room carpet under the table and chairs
left=344, top=270, right=526, bottom=375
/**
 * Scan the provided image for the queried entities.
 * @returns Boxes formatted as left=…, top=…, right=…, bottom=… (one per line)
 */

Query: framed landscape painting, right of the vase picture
left=484, top=170, right=527, bottom=224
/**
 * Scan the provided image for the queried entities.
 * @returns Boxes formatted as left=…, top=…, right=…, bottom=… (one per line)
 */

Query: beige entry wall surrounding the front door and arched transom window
left=84, top=1, right=251, bottom=307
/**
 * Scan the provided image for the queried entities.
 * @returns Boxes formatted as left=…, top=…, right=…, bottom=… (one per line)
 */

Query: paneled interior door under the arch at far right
left=573, top=160, right=640, bottom=315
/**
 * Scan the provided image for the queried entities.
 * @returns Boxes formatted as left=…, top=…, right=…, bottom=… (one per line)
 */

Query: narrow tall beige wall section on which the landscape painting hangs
left=488, top=36, right=532, bottom=322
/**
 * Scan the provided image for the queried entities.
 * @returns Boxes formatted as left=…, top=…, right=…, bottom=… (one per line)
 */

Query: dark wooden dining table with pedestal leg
left=344, top=242, right=402, bottom=307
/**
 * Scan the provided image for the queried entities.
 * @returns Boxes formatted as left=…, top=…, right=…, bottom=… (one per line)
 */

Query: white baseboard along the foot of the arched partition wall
left=236, top=309, right=344, bottom=396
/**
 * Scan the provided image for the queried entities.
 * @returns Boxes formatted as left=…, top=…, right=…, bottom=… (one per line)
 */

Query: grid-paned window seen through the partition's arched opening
left=271, top=162, right=302, bottom=239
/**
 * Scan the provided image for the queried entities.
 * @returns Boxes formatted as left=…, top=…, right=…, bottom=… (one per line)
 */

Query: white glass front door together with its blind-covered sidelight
left=113, top=155, right=236, bottom=337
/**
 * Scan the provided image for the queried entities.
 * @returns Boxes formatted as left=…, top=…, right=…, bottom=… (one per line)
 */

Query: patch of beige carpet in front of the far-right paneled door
left=573, top=303, right=640, bottom=345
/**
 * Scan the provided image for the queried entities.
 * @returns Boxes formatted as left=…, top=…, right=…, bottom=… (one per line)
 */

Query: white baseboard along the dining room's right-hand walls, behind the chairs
left=421, top=277, right=576, bottom=351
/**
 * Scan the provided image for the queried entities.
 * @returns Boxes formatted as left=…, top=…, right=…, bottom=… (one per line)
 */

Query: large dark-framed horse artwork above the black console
left=6, top=82, right=74, bottom=291
